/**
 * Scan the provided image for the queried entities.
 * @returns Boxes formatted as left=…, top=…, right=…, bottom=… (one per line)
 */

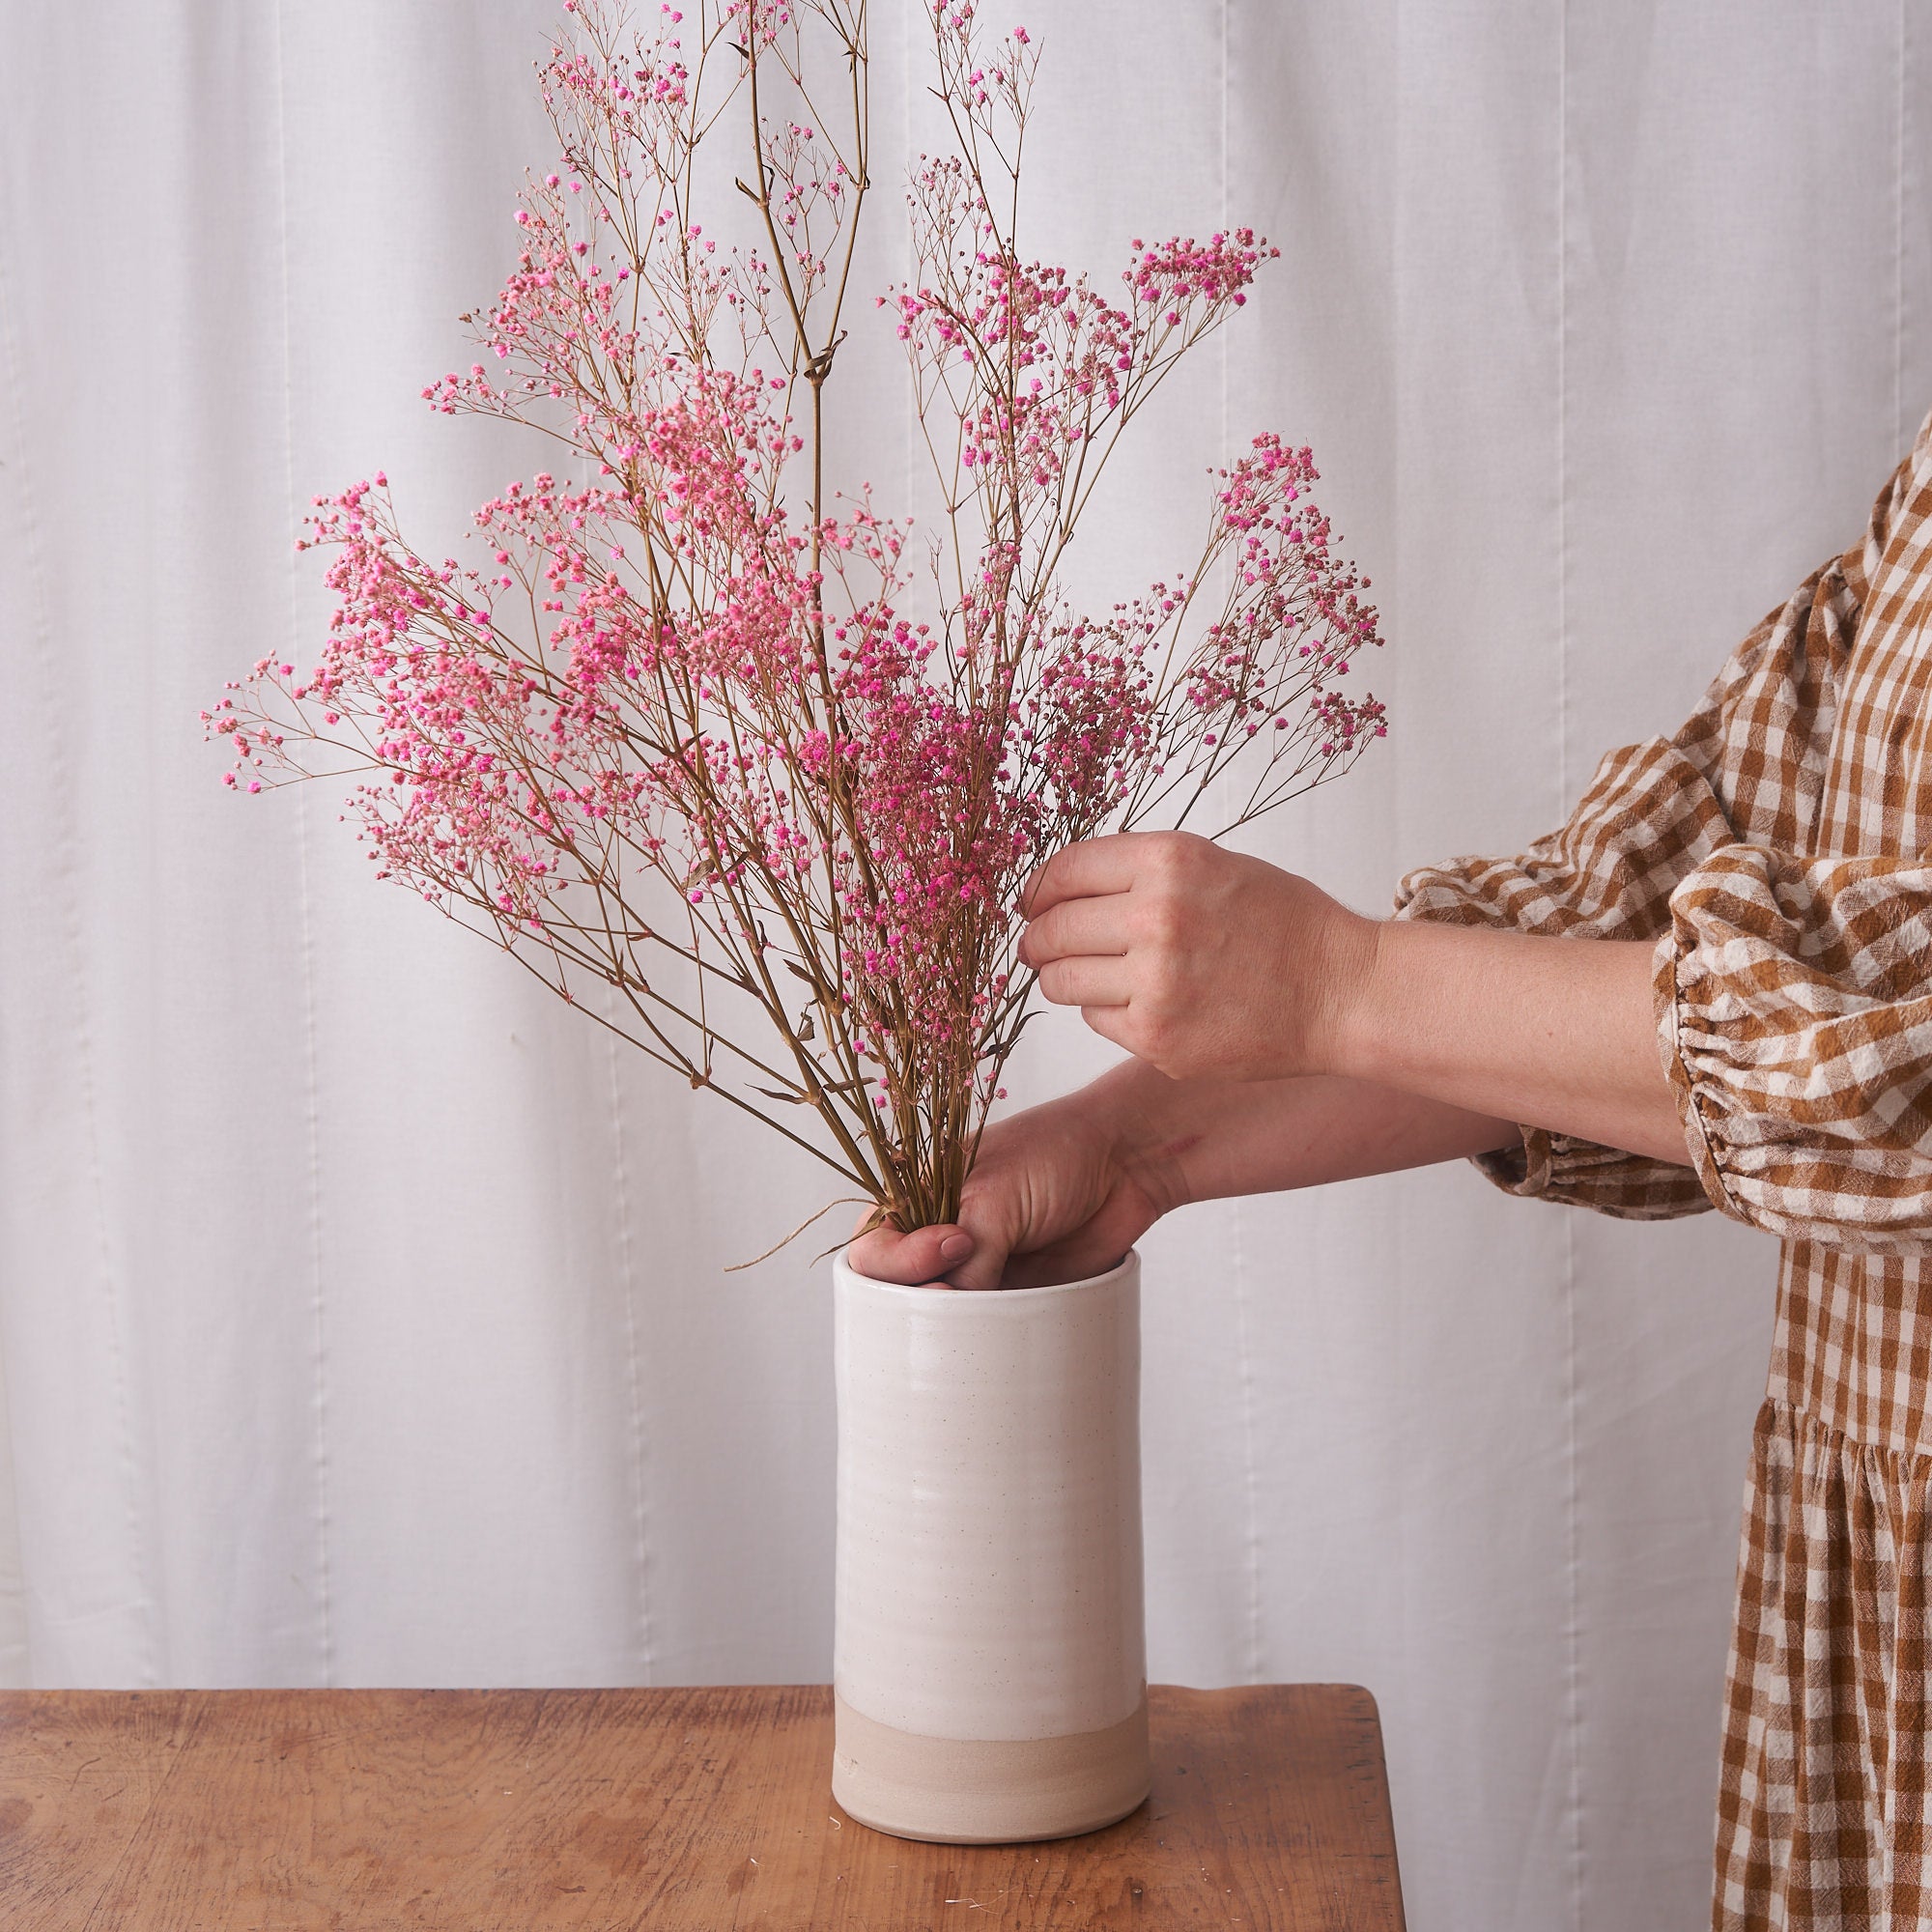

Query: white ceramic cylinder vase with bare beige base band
left=833, top=1254, right=1148, bottom=1845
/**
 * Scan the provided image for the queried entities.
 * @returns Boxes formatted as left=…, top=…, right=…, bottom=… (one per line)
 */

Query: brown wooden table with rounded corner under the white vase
left=0, top=1685, right=1403, bottom=1932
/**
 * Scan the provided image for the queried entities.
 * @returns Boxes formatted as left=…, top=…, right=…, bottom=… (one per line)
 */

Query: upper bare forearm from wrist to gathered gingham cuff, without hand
left=1325, top=920, right=1689, bottom=1163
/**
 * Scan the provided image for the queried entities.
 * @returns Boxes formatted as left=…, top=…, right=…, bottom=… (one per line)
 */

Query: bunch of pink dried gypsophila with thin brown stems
left=209, top=0, right=1383, bottom=1227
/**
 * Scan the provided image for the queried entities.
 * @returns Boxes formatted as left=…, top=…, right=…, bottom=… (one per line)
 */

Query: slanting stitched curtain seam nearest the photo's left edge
left=0, top=105, right=160, bottom=1685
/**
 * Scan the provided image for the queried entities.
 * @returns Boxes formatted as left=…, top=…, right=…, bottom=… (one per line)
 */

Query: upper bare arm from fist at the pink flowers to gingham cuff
left=1020, top=833, right=1689, bottom=1159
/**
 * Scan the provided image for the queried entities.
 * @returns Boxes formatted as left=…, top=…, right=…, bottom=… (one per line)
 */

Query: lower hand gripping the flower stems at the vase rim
left=848, top=1080, right=1180, bottom=1289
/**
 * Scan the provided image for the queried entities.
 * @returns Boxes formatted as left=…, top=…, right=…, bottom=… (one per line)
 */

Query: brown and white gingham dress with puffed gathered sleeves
left=1397, top=417, right=1932, bottom=1932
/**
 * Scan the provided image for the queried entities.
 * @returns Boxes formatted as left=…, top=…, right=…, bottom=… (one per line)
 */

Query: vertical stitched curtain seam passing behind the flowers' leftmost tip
left=274, top=0, right=336, bottom=1687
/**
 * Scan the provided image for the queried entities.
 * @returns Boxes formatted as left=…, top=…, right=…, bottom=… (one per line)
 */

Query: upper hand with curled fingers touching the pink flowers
left=1020, top=833, right=1379, bottom=1080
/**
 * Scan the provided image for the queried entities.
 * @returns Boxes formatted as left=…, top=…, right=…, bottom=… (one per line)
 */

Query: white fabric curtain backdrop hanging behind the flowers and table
left=0, top=0, right=1932, bottom=1932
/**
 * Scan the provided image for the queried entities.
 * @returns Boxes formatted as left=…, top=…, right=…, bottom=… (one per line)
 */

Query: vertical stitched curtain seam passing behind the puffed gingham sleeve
left=1555, top=0, right=1588, bottom=1928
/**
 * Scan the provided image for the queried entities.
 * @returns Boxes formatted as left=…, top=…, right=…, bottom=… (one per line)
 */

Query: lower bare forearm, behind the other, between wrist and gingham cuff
left=1074, top=1061, right=1519, bottom=1211
